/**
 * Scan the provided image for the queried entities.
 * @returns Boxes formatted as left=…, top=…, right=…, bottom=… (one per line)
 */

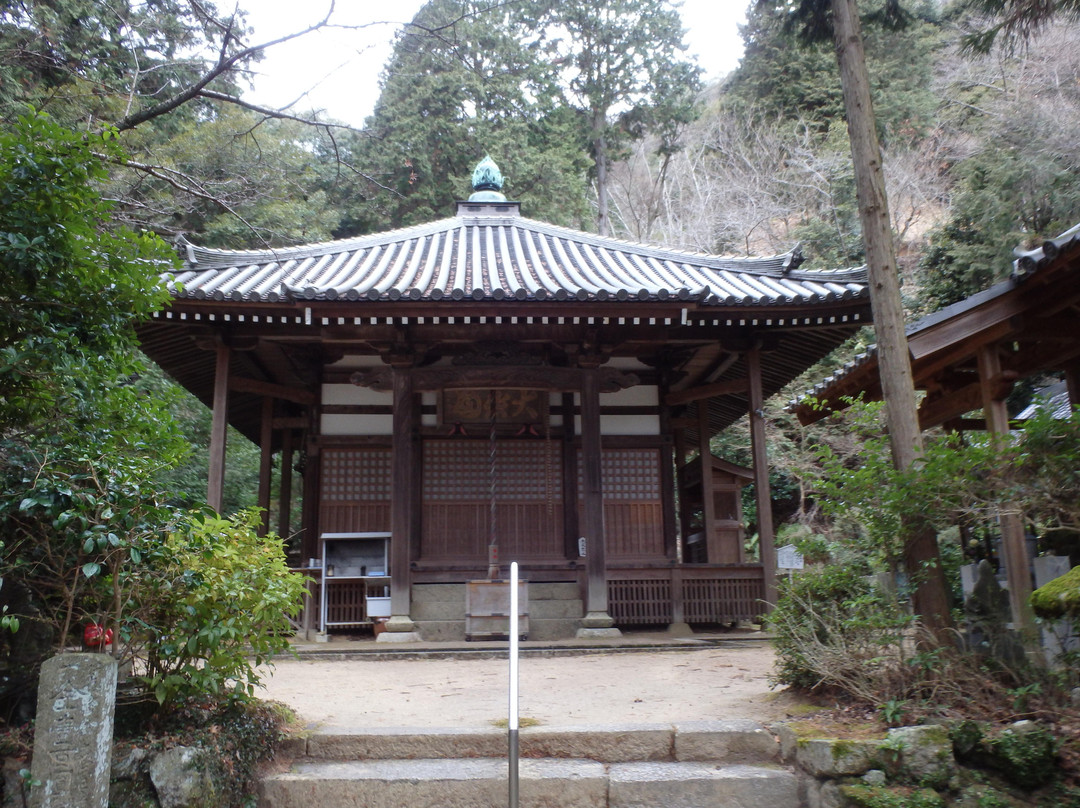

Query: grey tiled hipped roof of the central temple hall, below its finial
left=173, top=203, right=868, bottom=306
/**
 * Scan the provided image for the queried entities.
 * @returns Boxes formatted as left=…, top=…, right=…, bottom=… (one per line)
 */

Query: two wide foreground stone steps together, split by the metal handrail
left=258, top=721, right=800, bottom=808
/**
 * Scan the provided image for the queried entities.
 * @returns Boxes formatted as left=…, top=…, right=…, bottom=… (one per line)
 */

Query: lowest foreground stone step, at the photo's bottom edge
left=258, top=757, right=799, bottom=808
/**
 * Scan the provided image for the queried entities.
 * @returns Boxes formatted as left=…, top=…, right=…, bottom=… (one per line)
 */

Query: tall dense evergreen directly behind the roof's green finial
left=352, top=0, right=588, bottom=234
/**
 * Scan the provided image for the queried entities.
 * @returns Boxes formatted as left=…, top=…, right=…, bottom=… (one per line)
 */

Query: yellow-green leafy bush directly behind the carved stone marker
left=135, top=510, right=303, bottom=703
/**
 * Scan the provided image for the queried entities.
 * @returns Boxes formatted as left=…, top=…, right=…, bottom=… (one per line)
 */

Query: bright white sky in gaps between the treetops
left=239, top=0, right=750, bottom=126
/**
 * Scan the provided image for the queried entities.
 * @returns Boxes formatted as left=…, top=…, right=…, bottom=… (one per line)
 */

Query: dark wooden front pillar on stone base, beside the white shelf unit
left=388, top=367, right=419, bottom=642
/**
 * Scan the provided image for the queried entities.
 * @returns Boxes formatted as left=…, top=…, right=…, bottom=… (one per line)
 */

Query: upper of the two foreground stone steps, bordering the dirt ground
left=292, top=719, right=780, bottom=765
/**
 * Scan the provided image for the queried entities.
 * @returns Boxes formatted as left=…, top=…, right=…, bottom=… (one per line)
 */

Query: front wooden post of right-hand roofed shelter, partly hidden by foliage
left=977, top=345, right=1036, bottom=636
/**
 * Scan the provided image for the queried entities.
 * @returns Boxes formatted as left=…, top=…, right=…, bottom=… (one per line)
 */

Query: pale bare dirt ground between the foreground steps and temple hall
left=254, top=644, right=795, bottom=731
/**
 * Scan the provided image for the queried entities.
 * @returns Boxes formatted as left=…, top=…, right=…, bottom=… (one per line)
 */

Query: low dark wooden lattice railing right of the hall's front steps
left=607, top=564, right=767, bottom=625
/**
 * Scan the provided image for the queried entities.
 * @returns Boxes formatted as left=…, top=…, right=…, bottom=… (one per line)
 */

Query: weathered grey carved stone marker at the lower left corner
left=29, top=654, right=117, bottom=808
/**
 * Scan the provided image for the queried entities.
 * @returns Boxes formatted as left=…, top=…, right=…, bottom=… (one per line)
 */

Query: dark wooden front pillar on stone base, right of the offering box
left=581, top=367, right=615, bottom=631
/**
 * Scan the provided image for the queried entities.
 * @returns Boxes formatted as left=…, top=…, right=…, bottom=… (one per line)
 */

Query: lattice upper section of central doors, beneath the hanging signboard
left=423, top=441, right=563, bottom=503
